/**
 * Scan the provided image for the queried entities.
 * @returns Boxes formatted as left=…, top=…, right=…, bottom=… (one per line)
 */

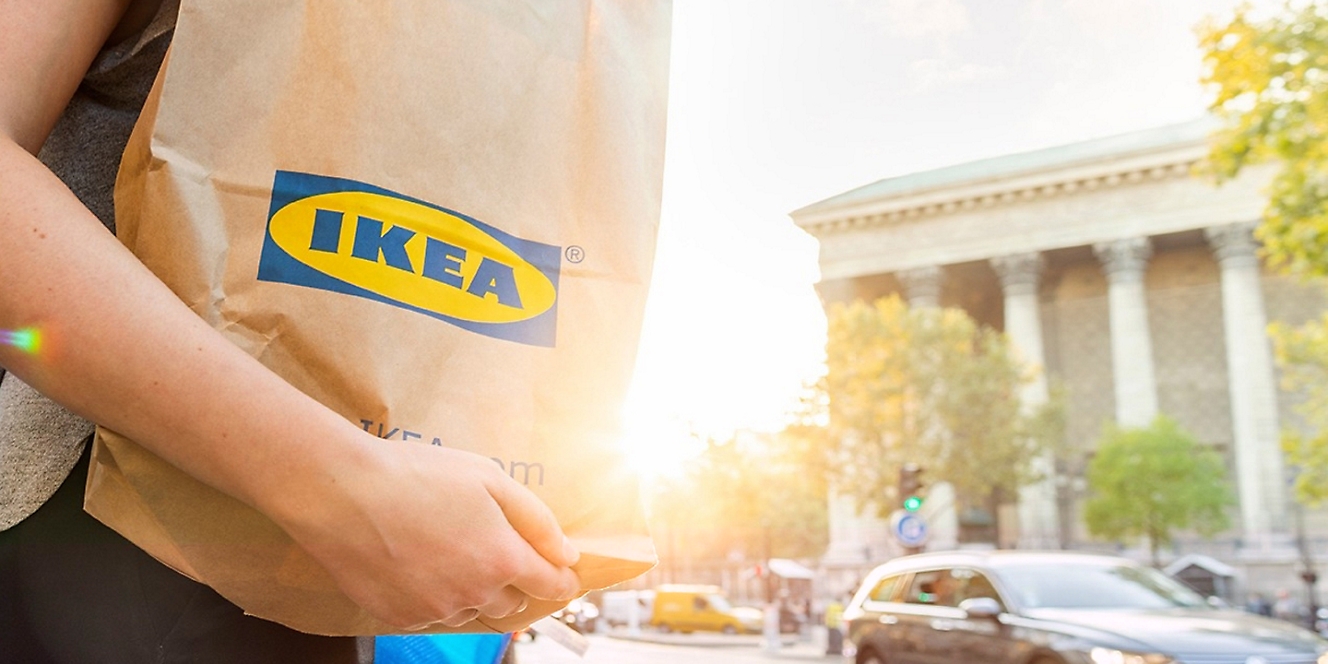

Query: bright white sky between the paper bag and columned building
left=616, top=0, right=1270, bottom=465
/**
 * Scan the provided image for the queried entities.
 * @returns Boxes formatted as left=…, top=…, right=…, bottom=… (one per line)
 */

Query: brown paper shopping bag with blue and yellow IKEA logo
left=86, top=0, right=671, bottom=635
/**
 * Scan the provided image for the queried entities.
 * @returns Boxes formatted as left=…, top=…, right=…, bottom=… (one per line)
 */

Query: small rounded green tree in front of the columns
left=1084, top=417, right=1235, bottom=564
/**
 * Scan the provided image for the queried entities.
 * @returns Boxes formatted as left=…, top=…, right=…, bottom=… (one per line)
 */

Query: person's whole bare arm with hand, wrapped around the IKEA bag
left=0, top=0, right=579, bottom=628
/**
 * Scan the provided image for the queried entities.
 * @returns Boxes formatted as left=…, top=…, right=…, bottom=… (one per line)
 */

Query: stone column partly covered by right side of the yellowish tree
left=991, top=252, right=1060, bottom=548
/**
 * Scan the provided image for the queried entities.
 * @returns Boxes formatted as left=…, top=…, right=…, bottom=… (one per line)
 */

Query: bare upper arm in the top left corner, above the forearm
left=0, top=0, right=145, bottom=153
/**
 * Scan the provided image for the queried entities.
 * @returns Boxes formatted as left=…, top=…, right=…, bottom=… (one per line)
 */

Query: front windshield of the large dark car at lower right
left=999, top=564, right=1207, bottom=608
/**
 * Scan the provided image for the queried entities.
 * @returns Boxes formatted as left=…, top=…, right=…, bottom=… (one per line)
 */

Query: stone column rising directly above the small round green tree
left=1093, top=238, right=1158, bottom=426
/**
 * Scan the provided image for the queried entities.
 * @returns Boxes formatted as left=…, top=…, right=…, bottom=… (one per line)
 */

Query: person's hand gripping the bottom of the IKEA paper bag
left=270, top=437, right=582, bottom=629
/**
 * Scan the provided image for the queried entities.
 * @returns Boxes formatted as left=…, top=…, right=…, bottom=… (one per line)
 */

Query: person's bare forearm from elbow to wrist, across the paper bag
left=0, top=137, right=366, bottom=511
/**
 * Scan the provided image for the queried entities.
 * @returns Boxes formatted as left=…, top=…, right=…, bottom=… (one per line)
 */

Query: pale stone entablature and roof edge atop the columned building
left=791, top=118, right=1271, bottom=280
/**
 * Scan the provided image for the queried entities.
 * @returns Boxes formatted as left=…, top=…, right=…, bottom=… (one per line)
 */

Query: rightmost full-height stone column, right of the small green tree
left=1204, top=223, right=1287, bottom=548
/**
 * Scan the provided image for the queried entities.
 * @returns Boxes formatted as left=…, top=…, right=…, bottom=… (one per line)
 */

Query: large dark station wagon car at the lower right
left=843, top=551, right=1328, bottom=664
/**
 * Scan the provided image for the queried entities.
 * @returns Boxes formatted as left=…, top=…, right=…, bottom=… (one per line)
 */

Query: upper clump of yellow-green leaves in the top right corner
left=1199, top=1, right=1328, bottom=276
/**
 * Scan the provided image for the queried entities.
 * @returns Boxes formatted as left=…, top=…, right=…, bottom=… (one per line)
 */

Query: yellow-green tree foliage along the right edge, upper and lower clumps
left=1199, top=0, right=1328, bottom=505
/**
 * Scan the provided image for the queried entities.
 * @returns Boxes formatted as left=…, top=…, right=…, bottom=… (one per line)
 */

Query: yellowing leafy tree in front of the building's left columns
left=818, top=296, right=1049, bottom=533
